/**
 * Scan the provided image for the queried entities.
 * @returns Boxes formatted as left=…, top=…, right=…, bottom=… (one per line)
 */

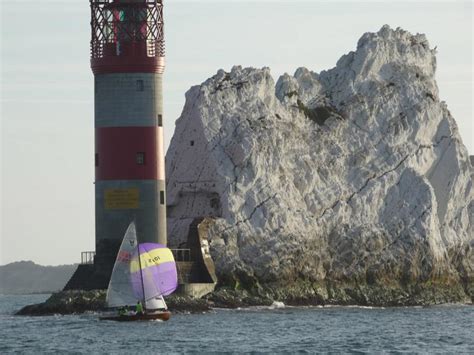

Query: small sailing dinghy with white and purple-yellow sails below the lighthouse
left=100, top=222, right=178, bottom=321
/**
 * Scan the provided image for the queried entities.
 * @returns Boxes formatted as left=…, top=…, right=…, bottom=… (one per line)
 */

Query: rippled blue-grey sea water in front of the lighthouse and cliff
left=0, top=295, right=474, bottom=354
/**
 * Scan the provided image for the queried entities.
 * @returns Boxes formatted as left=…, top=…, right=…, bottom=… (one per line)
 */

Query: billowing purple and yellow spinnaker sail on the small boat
left=131, top=243, right=178, bottom=300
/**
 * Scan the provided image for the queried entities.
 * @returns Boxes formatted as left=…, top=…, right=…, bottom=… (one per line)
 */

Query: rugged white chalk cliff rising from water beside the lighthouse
left=166, top=26, right=474, bottom=304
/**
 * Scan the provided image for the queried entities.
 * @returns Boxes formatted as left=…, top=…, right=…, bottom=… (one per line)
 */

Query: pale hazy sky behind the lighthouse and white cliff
left=0, top=0, right=474, bottom=265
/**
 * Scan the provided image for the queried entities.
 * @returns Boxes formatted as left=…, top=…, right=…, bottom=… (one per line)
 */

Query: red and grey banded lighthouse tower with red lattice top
left=90, top=0, right=166, bottom=269
